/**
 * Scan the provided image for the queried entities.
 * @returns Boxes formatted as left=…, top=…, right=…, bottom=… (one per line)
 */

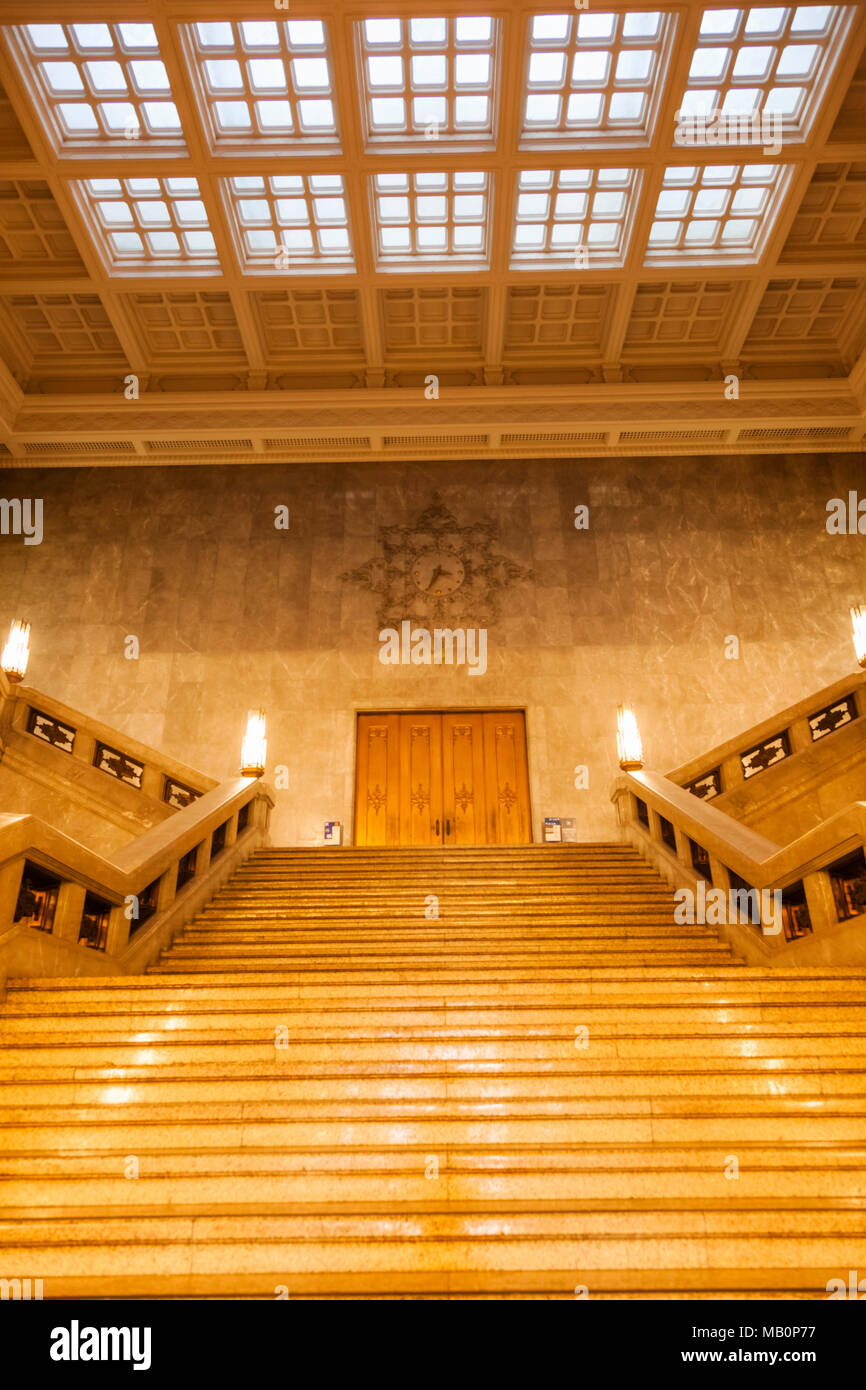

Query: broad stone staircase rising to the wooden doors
left=0, top=844, right=866, bottom=1298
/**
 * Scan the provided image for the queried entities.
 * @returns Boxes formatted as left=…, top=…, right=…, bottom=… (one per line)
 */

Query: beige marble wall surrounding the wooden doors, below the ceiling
left=0, top=455, right=866, bottom=844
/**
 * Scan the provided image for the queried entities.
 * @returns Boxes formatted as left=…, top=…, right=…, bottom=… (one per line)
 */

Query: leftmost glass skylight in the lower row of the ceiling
left=72, top=177, right=220, bottom=271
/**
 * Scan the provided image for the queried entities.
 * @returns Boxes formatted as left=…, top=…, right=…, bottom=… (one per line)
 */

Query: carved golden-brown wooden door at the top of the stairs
left=354, top=710, right=532, bottom=845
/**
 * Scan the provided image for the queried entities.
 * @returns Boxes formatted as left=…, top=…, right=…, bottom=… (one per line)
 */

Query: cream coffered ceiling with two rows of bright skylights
left=0, top=0, right=866, bottom=467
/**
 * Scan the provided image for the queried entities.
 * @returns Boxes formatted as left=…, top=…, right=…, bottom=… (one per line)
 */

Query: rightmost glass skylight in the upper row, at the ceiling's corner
left=680, top=6, right=851, bottom=139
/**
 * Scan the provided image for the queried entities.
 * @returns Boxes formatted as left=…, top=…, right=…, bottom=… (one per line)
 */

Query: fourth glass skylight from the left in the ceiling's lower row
left=512, top=168, right=639, bottom=268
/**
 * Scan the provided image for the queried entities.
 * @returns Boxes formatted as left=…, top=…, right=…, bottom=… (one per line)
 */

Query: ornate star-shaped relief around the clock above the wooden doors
left=341, top=492, right=534, bottom=627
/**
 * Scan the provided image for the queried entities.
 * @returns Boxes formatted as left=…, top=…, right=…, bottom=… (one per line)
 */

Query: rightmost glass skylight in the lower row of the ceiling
left=646, top=164, right=791, bottom=265
